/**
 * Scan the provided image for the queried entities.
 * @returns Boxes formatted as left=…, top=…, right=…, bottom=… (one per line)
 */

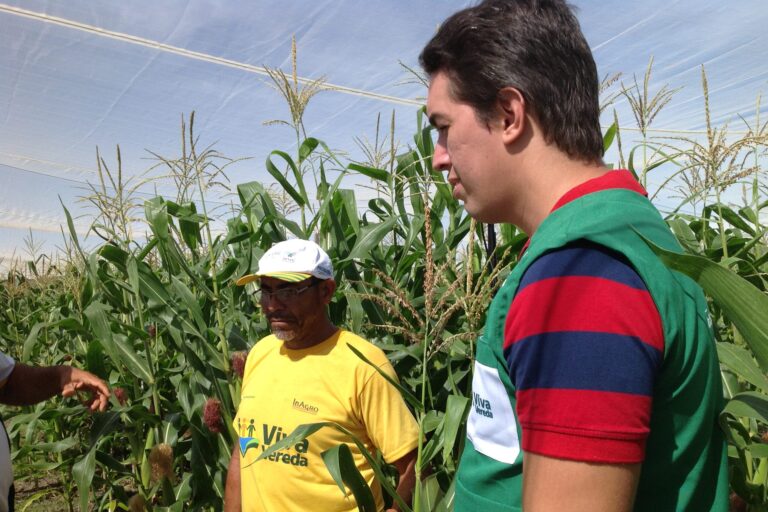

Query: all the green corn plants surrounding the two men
left=0, top=53, right=768, bottom=511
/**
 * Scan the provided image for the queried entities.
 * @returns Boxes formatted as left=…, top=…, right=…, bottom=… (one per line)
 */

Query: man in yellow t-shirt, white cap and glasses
left=224, top=240, right=418, bottom=512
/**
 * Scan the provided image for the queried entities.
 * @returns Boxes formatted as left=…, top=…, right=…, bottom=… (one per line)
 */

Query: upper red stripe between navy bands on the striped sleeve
left=504, top=276, right=664, bottom=351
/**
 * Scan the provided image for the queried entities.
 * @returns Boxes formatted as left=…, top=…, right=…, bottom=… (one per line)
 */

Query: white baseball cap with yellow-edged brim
left=237, top=239, right=333, bottom=286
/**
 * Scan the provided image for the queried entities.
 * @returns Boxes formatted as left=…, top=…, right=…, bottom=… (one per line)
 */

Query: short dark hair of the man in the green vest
left=419, top=0, right=603, bottom=162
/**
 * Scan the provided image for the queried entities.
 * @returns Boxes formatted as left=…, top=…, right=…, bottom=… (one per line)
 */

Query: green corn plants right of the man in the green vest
left=622, top=66, right=768, bottom=510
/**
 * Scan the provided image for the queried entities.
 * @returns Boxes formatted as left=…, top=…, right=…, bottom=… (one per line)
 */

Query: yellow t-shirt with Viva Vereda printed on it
left=233, top=330, right=418, bottom=512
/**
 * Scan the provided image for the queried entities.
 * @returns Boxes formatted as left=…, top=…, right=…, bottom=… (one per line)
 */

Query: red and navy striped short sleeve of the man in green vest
left=504, top=242, right=664, bottom=464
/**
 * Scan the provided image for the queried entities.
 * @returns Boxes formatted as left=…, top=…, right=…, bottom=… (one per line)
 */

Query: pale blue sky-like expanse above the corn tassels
left=0, top=0, right=768, bottom=268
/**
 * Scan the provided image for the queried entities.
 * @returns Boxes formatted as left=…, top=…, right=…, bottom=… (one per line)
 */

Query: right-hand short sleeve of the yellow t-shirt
left=359, top=356, right=419, bottom=463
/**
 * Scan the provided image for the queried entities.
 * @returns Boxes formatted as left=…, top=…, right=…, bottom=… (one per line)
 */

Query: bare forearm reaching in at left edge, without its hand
left=0, top=363, right=67, bottom=405
